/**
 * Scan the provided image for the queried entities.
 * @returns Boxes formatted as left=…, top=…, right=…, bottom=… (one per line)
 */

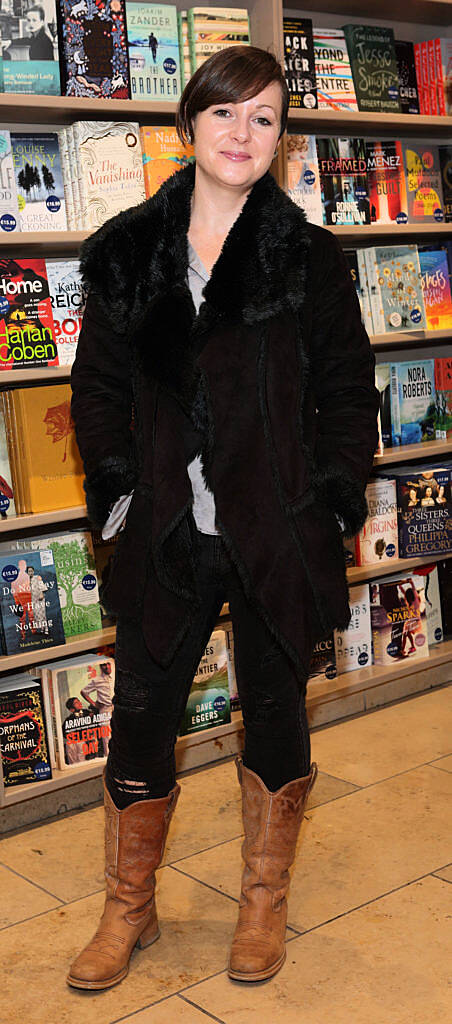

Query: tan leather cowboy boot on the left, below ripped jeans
left=67, top=782, right=180, bottom=989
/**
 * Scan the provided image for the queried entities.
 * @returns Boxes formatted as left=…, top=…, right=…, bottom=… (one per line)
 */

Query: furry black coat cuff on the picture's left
left=83, top=456, right=136, bottom=529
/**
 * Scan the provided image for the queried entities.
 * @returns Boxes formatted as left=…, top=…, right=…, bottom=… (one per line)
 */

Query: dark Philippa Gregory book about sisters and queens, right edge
left=394, top=466, right=452, bottom=558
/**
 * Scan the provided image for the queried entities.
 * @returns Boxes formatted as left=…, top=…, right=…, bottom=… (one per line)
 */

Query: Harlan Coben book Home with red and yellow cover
left=0, top=258, right=58, bottom=373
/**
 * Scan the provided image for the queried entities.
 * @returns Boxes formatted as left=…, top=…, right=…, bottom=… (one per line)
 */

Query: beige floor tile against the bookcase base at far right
left=312, top=687, right=451, bottom=785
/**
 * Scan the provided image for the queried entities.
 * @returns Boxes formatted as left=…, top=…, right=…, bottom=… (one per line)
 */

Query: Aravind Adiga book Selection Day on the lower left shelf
left=47, top=654, right=115, bottom=771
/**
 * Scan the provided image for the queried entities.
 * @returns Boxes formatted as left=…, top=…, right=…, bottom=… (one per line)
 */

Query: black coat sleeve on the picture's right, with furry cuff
left=310, top=230, right=379, bottom=537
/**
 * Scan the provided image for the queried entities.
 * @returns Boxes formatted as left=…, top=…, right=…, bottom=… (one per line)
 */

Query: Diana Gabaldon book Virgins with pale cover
left=355, top=478, right=399, bottom=565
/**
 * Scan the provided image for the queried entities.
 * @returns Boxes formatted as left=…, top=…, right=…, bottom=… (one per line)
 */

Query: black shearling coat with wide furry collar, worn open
left=72, top=166, right=378, bottom=672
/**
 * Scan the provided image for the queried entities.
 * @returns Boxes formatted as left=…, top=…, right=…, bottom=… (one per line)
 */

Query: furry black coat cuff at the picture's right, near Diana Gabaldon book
left=313, top=466, right=369, bottom=537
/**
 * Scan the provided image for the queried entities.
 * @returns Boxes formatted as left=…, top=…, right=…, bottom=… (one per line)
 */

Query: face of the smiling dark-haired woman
left=194, top=82, right=282, bottom=190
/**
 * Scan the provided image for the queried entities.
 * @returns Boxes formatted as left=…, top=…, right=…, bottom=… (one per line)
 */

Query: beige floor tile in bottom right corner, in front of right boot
left=189, top=878, right=452, bottom=1024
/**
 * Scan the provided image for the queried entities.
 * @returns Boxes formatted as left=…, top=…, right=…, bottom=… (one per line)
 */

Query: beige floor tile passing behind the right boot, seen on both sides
left=175, top=766, right=452, bottom=931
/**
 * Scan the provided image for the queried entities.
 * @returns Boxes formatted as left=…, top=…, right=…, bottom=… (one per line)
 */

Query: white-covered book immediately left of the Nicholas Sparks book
left=334, top=583, right=372, bottom=675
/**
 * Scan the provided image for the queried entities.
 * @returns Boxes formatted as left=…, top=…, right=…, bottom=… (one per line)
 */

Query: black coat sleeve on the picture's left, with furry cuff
left=71, top=288, right=137, bottom=528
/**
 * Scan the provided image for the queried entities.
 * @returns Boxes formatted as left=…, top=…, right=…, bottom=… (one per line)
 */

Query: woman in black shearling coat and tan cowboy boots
left=68, top=46, right=378, bottom=988
